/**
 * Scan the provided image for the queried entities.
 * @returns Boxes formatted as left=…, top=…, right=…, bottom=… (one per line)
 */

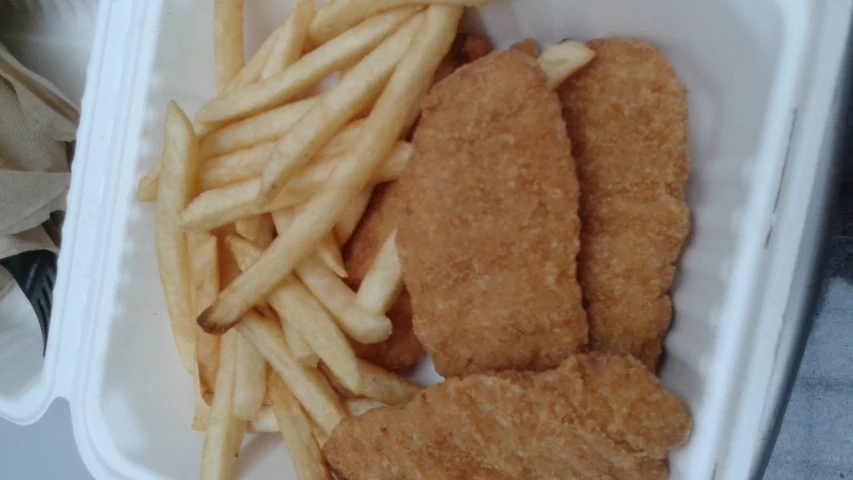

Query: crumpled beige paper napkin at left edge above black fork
left=0, top=44, right=79, bottom=290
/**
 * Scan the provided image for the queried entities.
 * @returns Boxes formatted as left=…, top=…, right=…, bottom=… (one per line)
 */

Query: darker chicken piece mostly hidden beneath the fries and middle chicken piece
left=343, top=33, right=492, bottom=374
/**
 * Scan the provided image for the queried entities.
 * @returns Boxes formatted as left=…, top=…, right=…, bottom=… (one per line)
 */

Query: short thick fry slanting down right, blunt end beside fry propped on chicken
left=296, top=256, right=392, bottom=343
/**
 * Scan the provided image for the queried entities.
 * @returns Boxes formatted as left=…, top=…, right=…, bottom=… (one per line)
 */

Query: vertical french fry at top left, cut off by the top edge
left=213, top=0, right=243, bottom=91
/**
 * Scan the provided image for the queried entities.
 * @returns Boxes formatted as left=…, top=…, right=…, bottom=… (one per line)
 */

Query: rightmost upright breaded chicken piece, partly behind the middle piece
left=559, top=39, right=690, bottom=369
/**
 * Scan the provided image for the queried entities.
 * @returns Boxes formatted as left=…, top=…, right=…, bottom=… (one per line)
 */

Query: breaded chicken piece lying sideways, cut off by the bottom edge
left=323, top=353, right=691, bottom=480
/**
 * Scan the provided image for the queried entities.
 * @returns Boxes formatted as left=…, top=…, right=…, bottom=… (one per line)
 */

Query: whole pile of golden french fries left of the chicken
left=137, top=0, right=591, bottom=480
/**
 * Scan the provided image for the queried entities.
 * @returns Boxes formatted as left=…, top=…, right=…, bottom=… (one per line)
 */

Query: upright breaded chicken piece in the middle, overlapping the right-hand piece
left=397, top=51, right=587, bottom=376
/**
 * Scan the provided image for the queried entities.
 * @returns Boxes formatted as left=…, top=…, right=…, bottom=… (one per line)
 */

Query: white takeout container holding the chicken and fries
left=0, top=0, right=853, bottom=480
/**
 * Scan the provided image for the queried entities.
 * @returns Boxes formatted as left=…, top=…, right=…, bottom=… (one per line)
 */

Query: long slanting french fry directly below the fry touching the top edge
left=196, top=7, right=417, bottom=122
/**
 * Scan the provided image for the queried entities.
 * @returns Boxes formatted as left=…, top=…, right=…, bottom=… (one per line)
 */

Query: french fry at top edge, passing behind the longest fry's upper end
left=309, top=0, right=491, bottom=45
